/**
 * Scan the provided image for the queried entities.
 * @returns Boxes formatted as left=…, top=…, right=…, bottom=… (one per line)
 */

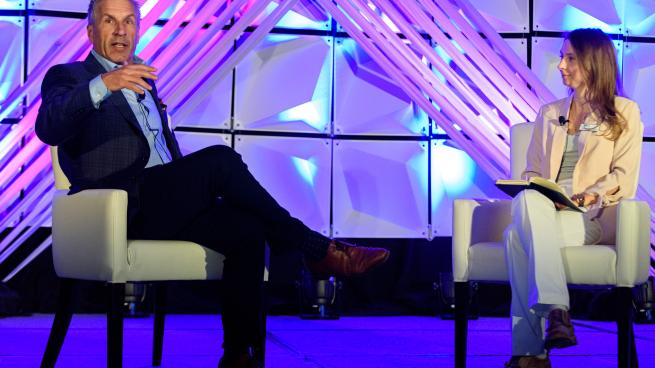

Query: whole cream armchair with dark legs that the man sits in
left=41, top=147, right=265, bottom=367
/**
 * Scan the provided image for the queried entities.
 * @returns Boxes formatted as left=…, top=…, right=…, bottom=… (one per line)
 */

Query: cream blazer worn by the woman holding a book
left=522, top=96, right=643, bottom=241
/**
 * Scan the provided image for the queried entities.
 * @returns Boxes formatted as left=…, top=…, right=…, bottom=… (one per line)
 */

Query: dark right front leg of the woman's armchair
left=615, top=287, right=639, bottom=368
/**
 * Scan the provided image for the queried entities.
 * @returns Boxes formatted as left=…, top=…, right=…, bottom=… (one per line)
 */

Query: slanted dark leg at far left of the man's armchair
left=41, top=279, right=74, bottom=368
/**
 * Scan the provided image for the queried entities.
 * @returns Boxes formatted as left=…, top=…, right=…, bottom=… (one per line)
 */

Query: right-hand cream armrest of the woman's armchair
left=616, top=199, right=650, bottom=287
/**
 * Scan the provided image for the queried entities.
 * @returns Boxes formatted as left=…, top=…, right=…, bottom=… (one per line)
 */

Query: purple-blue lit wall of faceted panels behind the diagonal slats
left=0, top=0, right=655, bottom=239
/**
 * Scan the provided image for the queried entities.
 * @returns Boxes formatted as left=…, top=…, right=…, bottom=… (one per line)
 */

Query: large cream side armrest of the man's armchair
left=52, top=189, right=127, bottom=282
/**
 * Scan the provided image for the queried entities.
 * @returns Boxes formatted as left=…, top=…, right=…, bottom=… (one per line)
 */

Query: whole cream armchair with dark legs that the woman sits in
left=452, top=123, right=650, bottom=368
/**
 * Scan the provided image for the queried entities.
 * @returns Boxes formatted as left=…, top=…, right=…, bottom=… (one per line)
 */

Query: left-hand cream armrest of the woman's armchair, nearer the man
left=453, top=199, right=512, bottom=282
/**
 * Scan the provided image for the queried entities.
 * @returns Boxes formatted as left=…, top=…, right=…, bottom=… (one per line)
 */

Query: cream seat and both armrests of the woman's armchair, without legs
left=453, top=200, right=650, bottom=287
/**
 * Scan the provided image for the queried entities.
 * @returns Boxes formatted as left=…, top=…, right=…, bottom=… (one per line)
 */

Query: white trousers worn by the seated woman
left=504, top=190, right=601, bottom=355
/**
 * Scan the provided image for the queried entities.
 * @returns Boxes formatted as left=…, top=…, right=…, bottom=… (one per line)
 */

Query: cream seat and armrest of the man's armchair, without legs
left=52, top=189, right=225, bottom=283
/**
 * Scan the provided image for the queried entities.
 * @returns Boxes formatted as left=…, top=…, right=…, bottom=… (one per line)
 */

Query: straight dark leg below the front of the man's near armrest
left=107, top=283, right=125, bottom=368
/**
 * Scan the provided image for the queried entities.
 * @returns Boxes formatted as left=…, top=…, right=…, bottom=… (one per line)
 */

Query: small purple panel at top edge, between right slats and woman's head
left=469, top=0, right=530, bottom=33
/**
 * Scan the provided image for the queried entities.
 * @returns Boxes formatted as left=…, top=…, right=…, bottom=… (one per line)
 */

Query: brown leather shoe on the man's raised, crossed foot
left=307, top=240, right=389, bottom=276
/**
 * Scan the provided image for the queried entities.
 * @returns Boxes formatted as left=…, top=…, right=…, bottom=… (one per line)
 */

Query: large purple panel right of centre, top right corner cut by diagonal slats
left=334, top=38, right=429, bottom=136
